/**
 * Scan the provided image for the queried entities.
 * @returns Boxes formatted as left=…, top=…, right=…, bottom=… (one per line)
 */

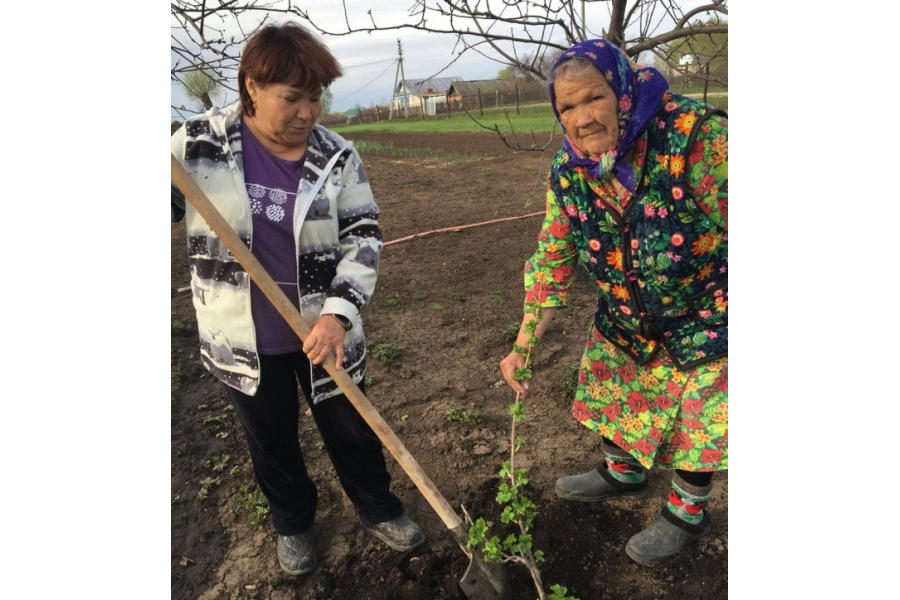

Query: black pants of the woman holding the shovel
left=228, top=352, right=403, bottom=535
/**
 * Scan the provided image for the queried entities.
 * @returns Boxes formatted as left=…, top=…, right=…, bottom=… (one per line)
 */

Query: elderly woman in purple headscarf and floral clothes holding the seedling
left=500, top=40, right=728, bottom=566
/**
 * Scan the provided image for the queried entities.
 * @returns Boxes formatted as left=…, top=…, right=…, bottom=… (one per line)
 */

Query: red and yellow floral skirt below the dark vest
left=572, top=328, right=728, bottom=471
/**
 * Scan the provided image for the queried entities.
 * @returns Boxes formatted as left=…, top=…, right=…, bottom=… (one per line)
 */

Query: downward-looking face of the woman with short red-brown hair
left=247, top=78, right=322, bottom=148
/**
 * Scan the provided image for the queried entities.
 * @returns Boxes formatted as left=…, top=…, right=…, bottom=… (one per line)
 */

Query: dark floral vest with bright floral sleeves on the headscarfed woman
left=525, top=94, right=728, bottom=369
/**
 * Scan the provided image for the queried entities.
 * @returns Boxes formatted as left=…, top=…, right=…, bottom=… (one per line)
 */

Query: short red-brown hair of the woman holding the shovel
left=238, top=21, right=342, bottom=117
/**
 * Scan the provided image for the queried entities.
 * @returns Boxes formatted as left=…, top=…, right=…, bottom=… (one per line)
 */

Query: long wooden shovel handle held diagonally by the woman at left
left=172, top=155, right=462, bottom=531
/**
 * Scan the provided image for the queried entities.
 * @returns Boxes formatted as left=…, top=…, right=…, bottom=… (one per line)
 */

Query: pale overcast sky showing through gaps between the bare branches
left=172, top=0, right=716, bottom=118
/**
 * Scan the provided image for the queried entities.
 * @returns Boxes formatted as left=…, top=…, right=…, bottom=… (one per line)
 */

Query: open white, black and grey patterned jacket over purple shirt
left=172, top=103, right=382, bottom=402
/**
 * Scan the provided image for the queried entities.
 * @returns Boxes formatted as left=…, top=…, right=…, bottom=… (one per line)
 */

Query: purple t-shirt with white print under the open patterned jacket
left=241, top=122, right=303, bottom=354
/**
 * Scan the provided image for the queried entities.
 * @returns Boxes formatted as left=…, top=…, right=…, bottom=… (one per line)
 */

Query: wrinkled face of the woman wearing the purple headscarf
left=553, top=68, right=619, bottom=154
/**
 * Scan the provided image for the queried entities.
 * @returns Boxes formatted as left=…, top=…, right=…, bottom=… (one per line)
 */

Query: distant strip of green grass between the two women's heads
left=332, top=103, right=559, bottom=135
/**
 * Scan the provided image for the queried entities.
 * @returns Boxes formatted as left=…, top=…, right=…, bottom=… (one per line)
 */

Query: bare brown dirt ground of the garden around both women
left=171, top=133, right=728, bottom=600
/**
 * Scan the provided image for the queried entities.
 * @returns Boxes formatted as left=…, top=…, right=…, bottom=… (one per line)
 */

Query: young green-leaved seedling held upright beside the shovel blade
left=463, top=289, right=578, bottom=600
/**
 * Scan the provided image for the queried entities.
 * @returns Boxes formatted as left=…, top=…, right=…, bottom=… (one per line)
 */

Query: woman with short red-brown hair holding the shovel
left=172, top=23, right=425, bottom=575
